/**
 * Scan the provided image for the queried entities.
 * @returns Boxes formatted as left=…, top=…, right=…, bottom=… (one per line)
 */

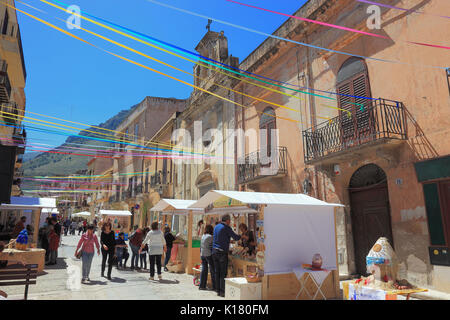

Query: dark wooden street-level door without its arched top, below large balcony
left=350, top=184, right=393, bottom=275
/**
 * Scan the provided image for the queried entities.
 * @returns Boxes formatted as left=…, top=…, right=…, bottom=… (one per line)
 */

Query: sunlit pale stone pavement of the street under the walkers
left=2, top=235, right=223, bottom=300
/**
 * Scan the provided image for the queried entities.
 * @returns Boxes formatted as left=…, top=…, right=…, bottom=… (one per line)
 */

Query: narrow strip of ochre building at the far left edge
left=0, top=0, right=27, bottom=203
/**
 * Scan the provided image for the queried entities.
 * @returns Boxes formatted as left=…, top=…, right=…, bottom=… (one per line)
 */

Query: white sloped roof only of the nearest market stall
left=190, top=190, right=343, bottom=209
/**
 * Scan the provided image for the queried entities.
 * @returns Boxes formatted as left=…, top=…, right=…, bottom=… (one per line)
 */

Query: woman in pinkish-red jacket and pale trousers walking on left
left=75, top=224, right=100, bottom=283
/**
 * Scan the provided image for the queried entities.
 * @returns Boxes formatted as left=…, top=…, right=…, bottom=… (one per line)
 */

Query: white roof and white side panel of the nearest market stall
left=191, top=190, right=343, bottom=274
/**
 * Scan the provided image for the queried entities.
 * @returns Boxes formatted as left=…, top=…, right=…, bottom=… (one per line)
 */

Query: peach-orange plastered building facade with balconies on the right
left=232, top=0, right=450, bottom=292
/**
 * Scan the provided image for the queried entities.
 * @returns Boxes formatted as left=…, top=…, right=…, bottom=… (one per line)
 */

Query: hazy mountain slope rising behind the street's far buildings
left=21, top=105, right=138, bottom=180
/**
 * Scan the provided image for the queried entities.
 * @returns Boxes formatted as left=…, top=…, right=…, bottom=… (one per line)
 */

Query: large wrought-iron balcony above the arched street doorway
left=303, top=98, right=407, bottom=164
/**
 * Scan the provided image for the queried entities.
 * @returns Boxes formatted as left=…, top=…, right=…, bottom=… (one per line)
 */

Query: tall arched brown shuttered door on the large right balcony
left=337, top=57, right=375, bottom=146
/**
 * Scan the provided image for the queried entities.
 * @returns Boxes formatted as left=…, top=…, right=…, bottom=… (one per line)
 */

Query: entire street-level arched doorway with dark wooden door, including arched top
left=349, top=164, right=393, bottom=275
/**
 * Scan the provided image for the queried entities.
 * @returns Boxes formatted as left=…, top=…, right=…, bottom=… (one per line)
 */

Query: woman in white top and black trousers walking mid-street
left=139, top=222, right=166, bottom=280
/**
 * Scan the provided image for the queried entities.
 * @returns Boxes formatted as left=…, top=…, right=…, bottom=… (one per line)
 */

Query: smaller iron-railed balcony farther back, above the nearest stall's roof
left=238, top=147, right=287, bottom=184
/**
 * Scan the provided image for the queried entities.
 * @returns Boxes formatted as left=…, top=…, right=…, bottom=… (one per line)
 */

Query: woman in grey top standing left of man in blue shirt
left=198, top=224, right=217, bottom=291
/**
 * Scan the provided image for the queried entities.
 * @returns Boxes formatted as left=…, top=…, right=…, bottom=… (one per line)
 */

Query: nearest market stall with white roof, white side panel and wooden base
left=191, top=190, right=342, bottom=300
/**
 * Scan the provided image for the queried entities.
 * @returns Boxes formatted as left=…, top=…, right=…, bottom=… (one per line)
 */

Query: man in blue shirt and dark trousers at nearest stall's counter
left=212, top=214, right=241, bottom=297
